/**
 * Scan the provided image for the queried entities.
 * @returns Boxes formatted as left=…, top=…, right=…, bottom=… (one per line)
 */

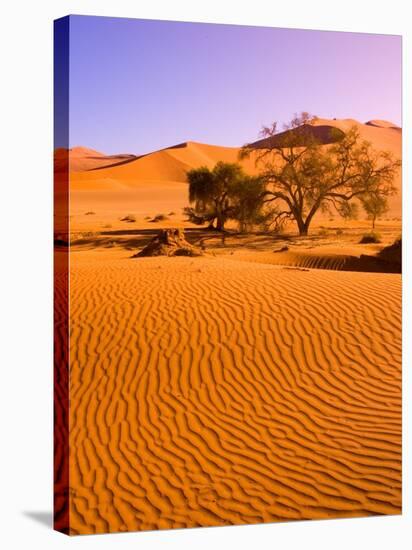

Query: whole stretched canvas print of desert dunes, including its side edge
left=54, top=16, right=402, bottom=535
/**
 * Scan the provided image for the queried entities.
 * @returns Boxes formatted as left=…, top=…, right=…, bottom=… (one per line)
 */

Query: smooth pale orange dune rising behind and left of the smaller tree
left=70, top=142, right=255, bottom=221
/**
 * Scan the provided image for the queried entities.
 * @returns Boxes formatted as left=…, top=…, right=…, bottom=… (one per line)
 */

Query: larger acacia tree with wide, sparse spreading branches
left=241, top=113, right=400, bottom=235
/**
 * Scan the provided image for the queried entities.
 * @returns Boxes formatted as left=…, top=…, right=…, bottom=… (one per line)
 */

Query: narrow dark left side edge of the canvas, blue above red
left=54, top=17, right=70, bottom=534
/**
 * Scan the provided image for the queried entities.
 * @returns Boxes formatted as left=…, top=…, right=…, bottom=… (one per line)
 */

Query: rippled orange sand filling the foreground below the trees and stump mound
left=63, top=252, right=401, bottom=534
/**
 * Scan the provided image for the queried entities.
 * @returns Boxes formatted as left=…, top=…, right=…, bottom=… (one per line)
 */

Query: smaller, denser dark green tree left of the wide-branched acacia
left=184, top=162, right=264, bottom=231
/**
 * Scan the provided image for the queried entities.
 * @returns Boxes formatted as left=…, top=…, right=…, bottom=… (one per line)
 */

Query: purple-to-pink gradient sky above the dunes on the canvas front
left=66, top=16, right=401, bottom=154
